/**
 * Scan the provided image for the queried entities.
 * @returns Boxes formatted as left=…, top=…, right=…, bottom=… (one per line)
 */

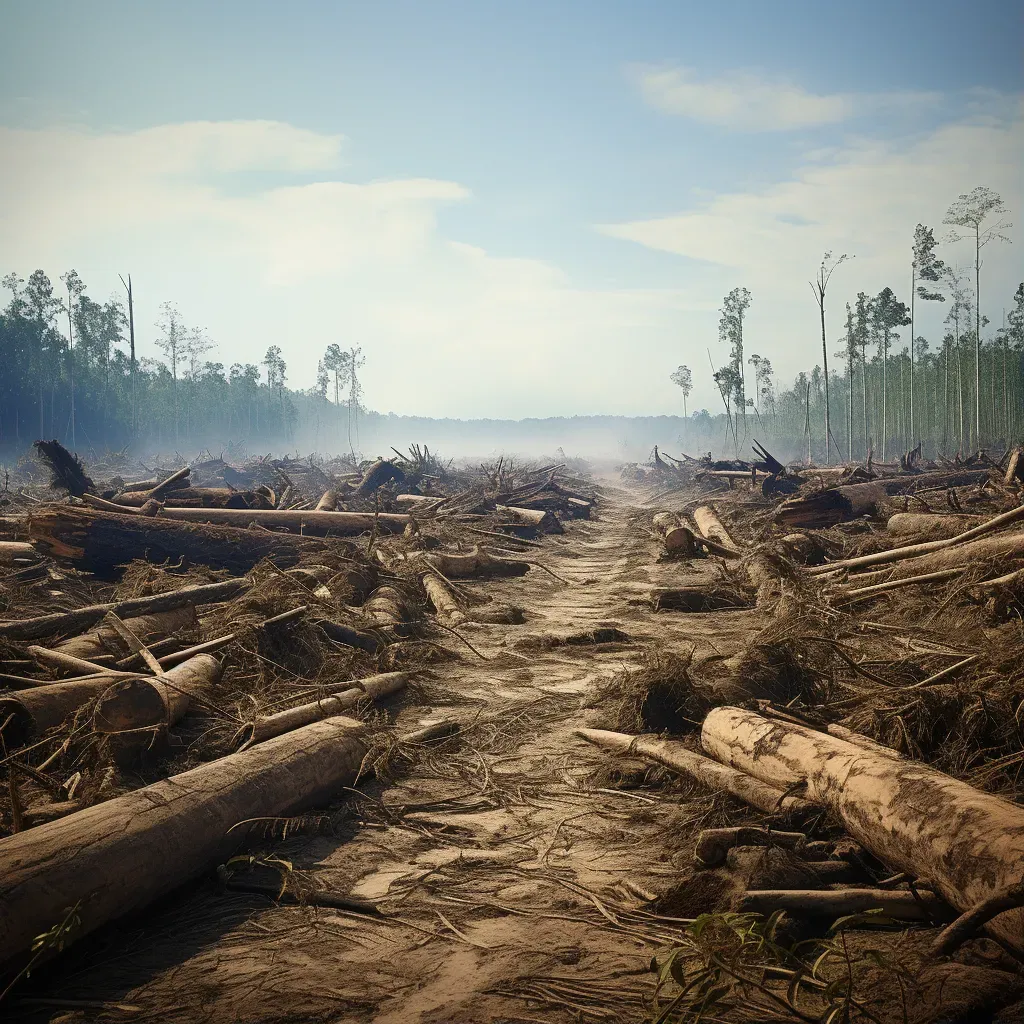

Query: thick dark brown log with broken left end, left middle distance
left=29, top=506, right=341, bottom=577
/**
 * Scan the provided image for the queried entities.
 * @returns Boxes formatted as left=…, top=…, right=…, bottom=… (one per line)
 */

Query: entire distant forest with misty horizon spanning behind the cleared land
left=0, top=188, right=1024, bottom=460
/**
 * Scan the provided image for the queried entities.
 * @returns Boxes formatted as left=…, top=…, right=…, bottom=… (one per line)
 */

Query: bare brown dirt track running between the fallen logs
left=10, top=486, right=1024, bottom=1024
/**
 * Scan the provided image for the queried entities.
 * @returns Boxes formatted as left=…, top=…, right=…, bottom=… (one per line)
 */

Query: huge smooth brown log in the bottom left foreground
left=0, top=718, right=367, bottom=962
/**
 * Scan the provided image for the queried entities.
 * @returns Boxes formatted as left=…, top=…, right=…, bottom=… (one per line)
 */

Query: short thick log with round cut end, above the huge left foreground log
left=92, top=654, right=222, bottom=735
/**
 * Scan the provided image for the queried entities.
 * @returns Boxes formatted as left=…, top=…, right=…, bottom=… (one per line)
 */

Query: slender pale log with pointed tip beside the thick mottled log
left=577, top=729, right=815, bottom=814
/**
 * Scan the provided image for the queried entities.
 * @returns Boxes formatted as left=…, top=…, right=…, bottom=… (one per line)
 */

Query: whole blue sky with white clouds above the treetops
left=0, top=0, right=1024, bottom=419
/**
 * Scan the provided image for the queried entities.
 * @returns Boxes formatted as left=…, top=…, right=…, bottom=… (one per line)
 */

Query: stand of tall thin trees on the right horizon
left=671, top=187, right=1024, bottom=462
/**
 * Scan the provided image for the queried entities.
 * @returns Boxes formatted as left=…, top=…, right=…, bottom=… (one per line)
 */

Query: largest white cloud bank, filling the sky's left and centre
left=0, top=122, right=685, bottom=417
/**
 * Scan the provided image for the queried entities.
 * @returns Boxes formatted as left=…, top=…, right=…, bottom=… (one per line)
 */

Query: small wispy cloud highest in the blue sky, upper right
left=635, top=68, right=936, bottom=131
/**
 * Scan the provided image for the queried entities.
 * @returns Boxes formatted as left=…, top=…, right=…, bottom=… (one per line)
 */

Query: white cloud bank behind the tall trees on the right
left=599, top=97, right=1024, bottom=387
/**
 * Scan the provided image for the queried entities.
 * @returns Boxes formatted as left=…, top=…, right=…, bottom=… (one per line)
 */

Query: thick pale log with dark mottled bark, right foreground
left=700, top=708, right=1024, bottom=952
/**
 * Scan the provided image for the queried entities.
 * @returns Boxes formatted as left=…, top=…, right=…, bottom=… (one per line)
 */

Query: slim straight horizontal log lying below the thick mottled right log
left=738, top=889, right=949, bottom=922
